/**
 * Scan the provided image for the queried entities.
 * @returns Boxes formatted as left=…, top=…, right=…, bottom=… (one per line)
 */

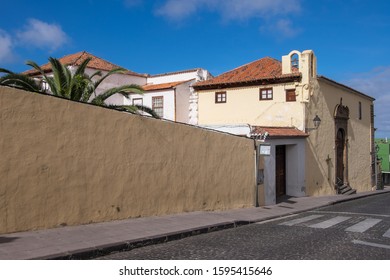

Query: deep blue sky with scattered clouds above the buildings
left=0, top=0, right=390, bottom=137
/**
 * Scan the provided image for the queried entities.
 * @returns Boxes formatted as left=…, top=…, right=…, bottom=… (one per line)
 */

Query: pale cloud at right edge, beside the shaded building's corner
left=344, top=66, right=390, bottom=137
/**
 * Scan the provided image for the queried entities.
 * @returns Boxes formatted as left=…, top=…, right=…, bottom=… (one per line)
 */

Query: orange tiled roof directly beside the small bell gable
left=194, top=57, right=301, bottom=89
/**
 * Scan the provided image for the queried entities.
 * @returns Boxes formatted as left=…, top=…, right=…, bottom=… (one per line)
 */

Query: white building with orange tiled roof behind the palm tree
left=25, top=51, right=211, bottom=124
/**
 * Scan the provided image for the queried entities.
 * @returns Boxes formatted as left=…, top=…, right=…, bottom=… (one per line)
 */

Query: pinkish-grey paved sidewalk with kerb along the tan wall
left=0, top=187, right=390, bottom=260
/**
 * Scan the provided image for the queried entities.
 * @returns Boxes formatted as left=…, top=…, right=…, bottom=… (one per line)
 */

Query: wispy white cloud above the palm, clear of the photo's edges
left=16, top=19, right=69, bottom=51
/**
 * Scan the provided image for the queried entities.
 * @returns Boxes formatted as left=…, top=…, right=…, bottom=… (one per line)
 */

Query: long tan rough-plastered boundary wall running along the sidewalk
left=0, top=87, right=255, bottom=233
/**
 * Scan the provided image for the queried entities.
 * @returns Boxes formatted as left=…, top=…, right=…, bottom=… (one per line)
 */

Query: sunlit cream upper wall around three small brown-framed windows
left=198, top=83, right=304, bottom=129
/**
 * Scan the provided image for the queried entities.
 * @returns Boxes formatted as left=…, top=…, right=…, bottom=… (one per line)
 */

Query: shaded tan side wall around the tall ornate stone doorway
left=306, top=79, right=372, bottom=195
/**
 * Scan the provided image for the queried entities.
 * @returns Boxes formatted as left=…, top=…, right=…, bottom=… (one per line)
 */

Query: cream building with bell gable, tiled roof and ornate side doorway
left=194, top=50, right=374, bottom=205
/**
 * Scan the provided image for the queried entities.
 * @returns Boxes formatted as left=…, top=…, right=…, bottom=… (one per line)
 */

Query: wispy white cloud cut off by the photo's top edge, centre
left=156, top=0, right=301, bottom=21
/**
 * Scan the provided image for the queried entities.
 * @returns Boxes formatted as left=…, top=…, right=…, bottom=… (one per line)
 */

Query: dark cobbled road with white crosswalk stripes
left=95, top=193, right=390, bottom=260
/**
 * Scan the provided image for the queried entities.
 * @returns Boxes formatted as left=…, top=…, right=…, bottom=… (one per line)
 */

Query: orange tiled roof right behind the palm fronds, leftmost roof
left=24, top=51, right=143, bottom=76
